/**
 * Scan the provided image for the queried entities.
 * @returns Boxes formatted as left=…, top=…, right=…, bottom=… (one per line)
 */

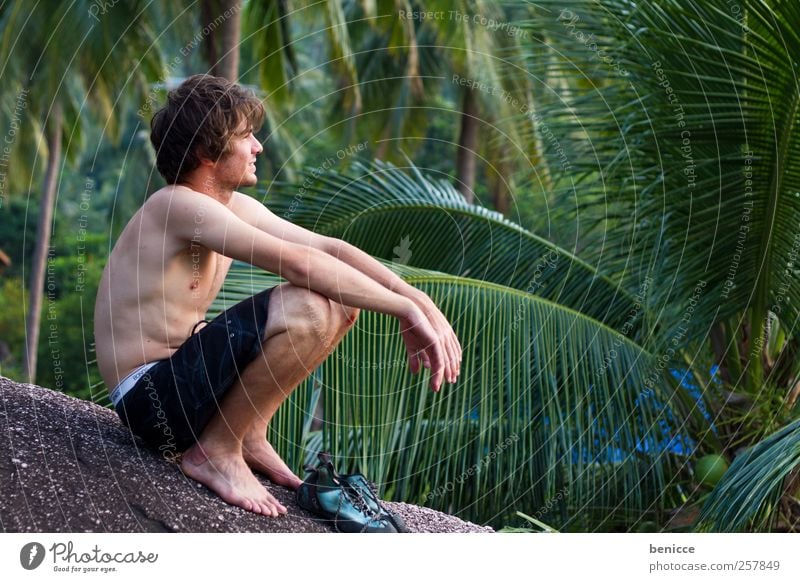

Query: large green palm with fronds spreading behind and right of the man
left=209, top=0, right=800, bottom=529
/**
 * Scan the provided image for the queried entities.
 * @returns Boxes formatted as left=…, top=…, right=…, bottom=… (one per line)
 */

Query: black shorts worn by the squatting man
left=116, top=289, right=272, bottom=457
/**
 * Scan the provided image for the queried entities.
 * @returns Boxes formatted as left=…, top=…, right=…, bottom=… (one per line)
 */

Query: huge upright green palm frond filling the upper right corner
left=525, top=0, right=800, bottom=362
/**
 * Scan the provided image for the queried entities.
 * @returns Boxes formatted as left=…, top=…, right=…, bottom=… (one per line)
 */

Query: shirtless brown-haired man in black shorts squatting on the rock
left=95, top=75, right=461, bottom=516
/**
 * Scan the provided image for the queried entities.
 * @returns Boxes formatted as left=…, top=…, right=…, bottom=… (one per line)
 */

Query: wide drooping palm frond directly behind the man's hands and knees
left=216, top=264, right=681, bottom=529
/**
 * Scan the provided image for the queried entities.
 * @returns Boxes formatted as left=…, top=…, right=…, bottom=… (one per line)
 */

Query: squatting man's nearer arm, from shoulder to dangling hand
left=165, top=189, right=449, bottom=391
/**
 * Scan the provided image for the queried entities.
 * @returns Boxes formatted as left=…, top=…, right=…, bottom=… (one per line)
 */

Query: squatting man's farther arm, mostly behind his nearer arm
left=234, top=193, right=462, bottom=383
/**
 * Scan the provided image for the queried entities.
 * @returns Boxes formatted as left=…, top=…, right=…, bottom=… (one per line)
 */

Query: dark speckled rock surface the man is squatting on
left=0, top=377, right=492, bottom=533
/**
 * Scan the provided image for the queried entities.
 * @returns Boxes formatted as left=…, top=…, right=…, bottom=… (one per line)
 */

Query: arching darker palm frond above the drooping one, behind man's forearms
left=267, top=160, right=641, bottom=337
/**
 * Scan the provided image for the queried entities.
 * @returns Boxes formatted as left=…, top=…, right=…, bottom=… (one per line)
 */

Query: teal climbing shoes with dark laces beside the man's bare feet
left=297, top=453, right=408, bottom=533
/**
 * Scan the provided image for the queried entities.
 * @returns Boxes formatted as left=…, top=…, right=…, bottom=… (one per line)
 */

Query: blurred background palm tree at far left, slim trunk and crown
left=0, top=0, right=159, bottom=382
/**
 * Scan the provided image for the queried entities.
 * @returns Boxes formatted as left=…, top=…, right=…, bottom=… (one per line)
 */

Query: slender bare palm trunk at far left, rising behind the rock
left=24, top=102, right=62, bottom=384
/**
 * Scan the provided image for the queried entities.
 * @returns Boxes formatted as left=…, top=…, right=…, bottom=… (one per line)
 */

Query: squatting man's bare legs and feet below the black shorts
left=181, top=284, right=360, bottom=515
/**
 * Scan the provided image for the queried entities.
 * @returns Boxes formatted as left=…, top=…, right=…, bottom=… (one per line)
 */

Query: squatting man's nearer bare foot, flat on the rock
left=181, top=443, right=286, bottom=517
